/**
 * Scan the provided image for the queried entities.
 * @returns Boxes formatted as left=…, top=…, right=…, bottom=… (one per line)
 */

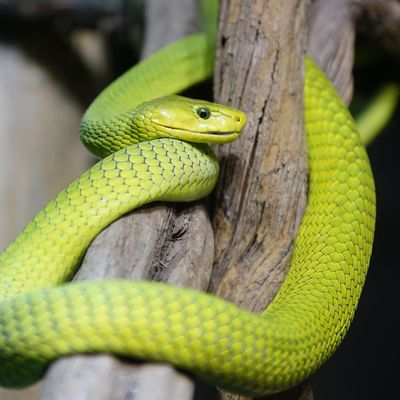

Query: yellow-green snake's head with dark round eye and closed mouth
left=136, top=95, right=247, bottom=143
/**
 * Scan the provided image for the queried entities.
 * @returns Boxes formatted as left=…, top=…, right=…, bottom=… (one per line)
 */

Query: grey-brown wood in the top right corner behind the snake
left=307, top=0, right=400, bottom=104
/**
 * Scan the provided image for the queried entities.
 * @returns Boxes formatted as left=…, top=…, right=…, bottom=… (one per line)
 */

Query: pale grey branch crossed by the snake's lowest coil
left=41, top=0, right=213, bottom=400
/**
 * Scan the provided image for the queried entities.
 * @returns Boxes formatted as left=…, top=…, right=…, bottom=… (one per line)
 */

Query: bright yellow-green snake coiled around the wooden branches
left=0, top=11, right=375, bottom=395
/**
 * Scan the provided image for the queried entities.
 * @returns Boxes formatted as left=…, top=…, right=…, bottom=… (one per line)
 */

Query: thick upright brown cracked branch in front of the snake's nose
left=211, top=0, right=308, bottom=399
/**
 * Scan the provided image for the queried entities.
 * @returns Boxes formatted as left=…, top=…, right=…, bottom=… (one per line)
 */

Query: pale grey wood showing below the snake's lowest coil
left=41, top=355, right=192, bottom=400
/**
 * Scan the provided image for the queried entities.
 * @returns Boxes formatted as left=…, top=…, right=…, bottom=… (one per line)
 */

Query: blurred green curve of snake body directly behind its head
left=80, top=33, right=214, bottom=158
